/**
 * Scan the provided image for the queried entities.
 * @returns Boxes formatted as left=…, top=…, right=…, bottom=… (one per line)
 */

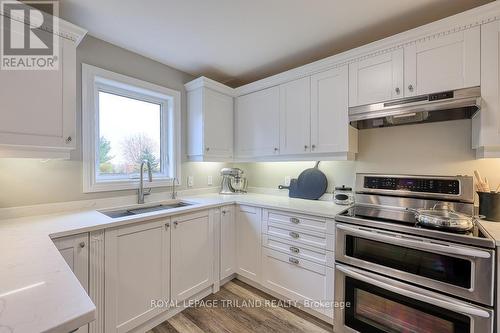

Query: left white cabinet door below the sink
left=104, top=220, right=170, bottom=333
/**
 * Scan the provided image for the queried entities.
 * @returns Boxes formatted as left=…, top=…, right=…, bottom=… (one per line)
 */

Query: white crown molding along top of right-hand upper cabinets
left=235, top=1, right=500, bottom=96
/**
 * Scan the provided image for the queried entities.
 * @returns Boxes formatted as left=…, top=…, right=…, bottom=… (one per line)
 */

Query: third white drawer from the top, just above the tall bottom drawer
left=262, top=235, right=334, bottom=267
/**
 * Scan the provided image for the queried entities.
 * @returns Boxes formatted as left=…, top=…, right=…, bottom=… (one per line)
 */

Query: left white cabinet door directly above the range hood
left=349, top=49, right=404, bottom=106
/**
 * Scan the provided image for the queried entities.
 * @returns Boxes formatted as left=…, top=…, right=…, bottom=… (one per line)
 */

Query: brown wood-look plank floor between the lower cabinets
left=148, top=280, right=333, bottom=333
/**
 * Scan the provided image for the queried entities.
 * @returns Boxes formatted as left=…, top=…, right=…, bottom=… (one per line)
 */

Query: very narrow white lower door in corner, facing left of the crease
left=219, top=206, right=237, bottom=280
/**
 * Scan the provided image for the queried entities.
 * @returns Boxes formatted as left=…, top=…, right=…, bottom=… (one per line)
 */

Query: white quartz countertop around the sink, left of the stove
left=0, top=194, right=348, bottom=333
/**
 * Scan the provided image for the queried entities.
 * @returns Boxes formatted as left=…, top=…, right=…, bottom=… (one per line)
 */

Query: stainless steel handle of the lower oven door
left=335, top=265, right=490, bottom=318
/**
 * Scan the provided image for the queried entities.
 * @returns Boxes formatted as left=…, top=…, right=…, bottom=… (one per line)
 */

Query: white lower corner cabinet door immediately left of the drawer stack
left=236, top=206, right=262, bottom=282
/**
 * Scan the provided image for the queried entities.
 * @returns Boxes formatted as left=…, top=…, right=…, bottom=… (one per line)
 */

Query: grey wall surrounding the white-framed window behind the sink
left=0, top=36, right=228, bottom=208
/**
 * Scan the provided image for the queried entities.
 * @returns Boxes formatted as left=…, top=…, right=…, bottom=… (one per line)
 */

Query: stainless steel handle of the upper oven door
left=337, top=224, right=491, bottom=259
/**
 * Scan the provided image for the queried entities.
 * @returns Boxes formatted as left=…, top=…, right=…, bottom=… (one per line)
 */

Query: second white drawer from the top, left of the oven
left=264, top=224, right=334, bottom=251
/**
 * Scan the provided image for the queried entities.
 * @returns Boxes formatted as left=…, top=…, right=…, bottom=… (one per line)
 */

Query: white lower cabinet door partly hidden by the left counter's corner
left=53, top=233, right=89, bottom=333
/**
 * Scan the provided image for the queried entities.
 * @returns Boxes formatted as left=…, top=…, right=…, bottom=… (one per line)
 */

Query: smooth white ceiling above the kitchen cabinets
left=60, top=0, right=491, bottom=86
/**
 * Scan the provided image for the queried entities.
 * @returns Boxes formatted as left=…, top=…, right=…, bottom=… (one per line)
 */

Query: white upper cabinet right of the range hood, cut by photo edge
left=472, top=21, right=500, bottom=158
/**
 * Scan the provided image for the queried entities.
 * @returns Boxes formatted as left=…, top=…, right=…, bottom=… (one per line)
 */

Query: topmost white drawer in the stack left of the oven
left=264, top=210, right=335, bottom=234
